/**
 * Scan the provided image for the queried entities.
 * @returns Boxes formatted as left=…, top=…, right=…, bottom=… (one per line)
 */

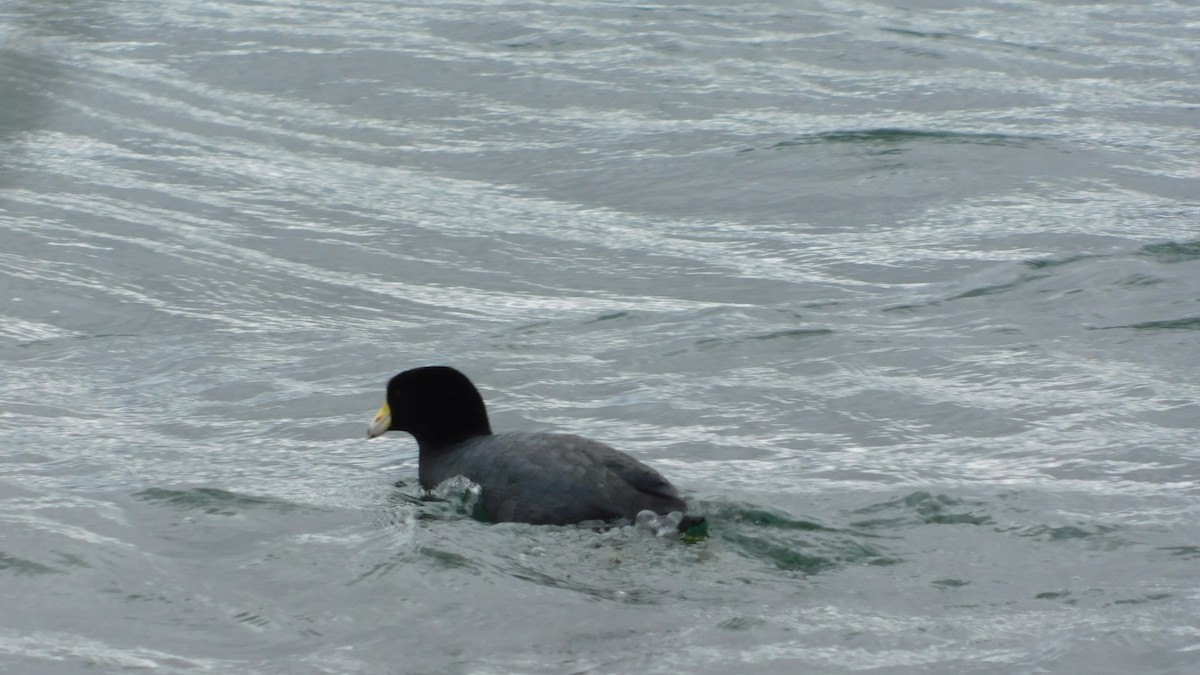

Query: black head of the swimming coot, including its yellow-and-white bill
left=367, top=365, right=492, bottom=452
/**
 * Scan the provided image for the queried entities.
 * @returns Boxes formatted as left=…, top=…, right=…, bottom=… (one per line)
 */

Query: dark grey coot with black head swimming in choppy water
left=367, top=366, right=703, bottom=528
